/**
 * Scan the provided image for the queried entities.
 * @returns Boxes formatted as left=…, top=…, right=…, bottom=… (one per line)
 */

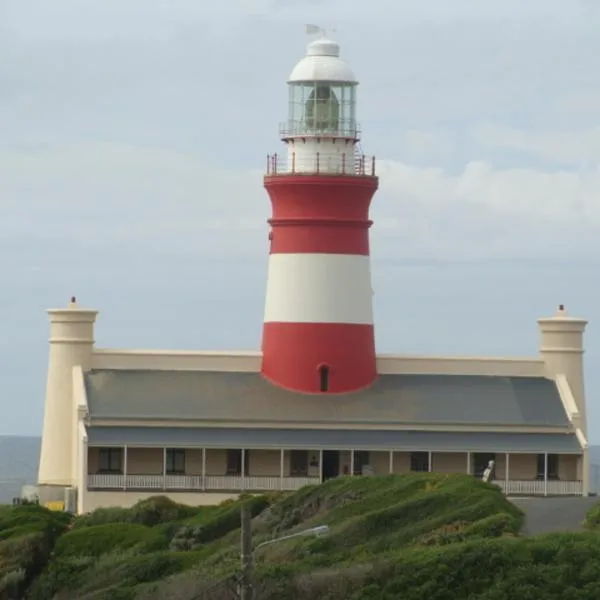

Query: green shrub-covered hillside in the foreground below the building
left=0, top=474, right=600, bottom=600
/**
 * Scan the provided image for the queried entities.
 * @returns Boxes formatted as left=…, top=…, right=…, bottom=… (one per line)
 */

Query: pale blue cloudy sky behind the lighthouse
left=0, top=0, right=600, bottom=443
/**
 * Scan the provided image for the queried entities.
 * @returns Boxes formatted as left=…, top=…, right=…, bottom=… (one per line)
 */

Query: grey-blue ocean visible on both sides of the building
left=0, top=435, right=600, bottom=504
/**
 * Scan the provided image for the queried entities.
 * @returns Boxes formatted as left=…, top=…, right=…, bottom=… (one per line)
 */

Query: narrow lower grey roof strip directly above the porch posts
left=88, top=426, right=581, bottom=453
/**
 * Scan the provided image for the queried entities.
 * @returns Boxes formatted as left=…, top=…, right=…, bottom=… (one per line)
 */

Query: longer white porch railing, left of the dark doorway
left=87, top=474, right=320, bottom=492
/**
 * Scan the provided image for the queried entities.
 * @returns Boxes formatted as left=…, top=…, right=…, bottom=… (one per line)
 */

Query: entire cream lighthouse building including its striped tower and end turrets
left=38, top=35, right=589, bottom=512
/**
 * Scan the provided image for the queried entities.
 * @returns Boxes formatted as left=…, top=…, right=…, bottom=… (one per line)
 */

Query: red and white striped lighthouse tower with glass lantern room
left=262, top=39, right=378, bottom=393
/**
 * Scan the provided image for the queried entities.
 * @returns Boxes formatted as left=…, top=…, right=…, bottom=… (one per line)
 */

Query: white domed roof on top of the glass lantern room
left=288, top=39, right=358, bottom=83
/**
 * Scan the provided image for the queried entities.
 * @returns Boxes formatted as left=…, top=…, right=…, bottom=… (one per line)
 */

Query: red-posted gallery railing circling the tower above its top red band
left=266, top=152, right=376, bottom=177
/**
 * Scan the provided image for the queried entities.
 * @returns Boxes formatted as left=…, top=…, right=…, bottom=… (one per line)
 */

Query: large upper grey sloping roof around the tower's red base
left=85, top=370, right=569, bottom=428
